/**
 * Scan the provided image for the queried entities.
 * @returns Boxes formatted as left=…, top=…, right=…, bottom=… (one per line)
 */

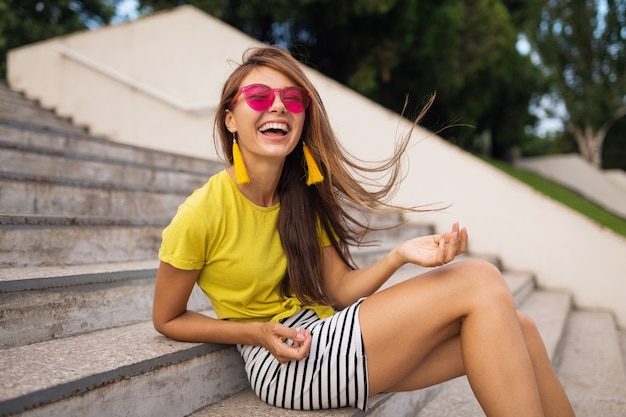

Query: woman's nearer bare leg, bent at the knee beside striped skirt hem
left=360, top=261, right=573, bottom=416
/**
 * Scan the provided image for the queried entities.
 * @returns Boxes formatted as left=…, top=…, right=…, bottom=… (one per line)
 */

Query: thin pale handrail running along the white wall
left=56, top=44, right=216, bottom=116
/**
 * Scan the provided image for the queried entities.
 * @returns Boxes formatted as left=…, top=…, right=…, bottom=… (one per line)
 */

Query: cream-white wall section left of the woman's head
left=8, top=7, right=258, bottom=158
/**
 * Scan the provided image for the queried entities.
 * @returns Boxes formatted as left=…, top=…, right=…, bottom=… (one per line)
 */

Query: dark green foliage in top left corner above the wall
left=0, top=0, right=120, bottom=78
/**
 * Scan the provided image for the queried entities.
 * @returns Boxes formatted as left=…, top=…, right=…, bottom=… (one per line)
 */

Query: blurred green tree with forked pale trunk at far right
left=528, top=0, right=626, bottom=167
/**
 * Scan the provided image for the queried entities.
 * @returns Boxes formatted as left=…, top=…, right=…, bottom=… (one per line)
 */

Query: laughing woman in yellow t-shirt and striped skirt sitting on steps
left=153, top=47, right=573, bottom=417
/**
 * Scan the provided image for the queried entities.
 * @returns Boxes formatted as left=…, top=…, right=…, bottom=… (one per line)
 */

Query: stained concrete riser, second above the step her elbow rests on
left=0, top=214, right=169, bottom=268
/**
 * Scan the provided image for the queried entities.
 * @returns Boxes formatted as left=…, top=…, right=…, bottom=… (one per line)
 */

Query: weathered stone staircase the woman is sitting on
left=0, top=85, right=626, bottom=417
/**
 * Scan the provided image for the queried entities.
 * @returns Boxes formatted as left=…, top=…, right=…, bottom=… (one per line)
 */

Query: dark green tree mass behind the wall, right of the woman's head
left=140, top=0, right=541, bottom=158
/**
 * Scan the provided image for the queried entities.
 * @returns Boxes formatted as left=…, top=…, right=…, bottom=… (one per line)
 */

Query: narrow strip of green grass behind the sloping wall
left=482, top=158, right=626, bottom=237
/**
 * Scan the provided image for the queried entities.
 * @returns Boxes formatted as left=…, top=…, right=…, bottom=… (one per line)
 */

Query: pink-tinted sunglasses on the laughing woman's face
left=230, top=84, right=311, bottom=113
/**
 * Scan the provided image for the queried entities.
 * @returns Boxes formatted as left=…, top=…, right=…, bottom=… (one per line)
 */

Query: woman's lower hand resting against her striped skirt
left=261, top=322, right=311, bottom=363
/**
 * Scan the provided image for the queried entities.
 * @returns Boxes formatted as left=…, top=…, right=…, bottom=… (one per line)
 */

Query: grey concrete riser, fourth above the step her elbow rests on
left=0, top=145, right=210, bottom=194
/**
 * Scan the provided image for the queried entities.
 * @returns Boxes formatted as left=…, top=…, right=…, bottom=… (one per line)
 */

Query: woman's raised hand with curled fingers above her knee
left=396, top=223, right=467, bottom=267
